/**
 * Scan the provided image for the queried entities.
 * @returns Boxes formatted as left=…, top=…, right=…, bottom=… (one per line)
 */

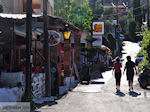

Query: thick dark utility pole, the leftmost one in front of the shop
left=25, top=0, right=32, bottom=102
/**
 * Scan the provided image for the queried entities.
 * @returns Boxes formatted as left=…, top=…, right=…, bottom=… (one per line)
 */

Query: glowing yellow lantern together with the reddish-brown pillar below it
left=63, top=25, right=71, bottom=77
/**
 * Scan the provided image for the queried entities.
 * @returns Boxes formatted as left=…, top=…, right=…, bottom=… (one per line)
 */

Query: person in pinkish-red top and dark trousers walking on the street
left=113, top=57, right=122, bottom=92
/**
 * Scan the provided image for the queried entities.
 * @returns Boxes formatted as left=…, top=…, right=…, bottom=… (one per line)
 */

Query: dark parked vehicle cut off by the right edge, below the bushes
left=138, top=68, right=150, bottom=88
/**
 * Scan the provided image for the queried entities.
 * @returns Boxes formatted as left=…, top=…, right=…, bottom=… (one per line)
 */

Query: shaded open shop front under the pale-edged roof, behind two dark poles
left=0, top=14, right=80, bottom=101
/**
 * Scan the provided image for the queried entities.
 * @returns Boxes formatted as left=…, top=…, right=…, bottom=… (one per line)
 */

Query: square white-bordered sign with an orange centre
left=93, top=22, right=104, bottom=35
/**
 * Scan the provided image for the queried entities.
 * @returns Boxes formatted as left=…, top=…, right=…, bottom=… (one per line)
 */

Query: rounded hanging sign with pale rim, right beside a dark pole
left=48, top=30, right=61, bottom=46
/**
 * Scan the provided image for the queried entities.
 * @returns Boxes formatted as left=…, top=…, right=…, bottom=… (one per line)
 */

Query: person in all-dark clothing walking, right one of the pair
left=123, top=56, right=137, bottom=92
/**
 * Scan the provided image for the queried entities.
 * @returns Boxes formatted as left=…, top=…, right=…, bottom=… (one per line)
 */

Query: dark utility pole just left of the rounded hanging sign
left=43, top=0, right=51, bottom=97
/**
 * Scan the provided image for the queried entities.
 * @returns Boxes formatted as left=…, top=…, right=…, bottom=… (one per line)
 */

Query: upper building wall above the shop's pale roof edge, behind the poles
left=0, top=0, right=54, bottom=16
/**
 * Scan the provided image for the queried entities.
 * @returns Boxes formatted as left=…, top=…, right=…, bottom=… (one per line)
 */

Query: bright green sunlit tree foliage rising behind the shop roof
left=54, top=0, right=93, bottom=30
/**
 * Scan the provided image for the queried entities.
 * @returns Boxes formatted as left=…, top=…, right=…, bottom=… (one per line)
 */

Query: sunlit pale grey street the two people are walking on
left=37, top=41, right=150, bottom=112
